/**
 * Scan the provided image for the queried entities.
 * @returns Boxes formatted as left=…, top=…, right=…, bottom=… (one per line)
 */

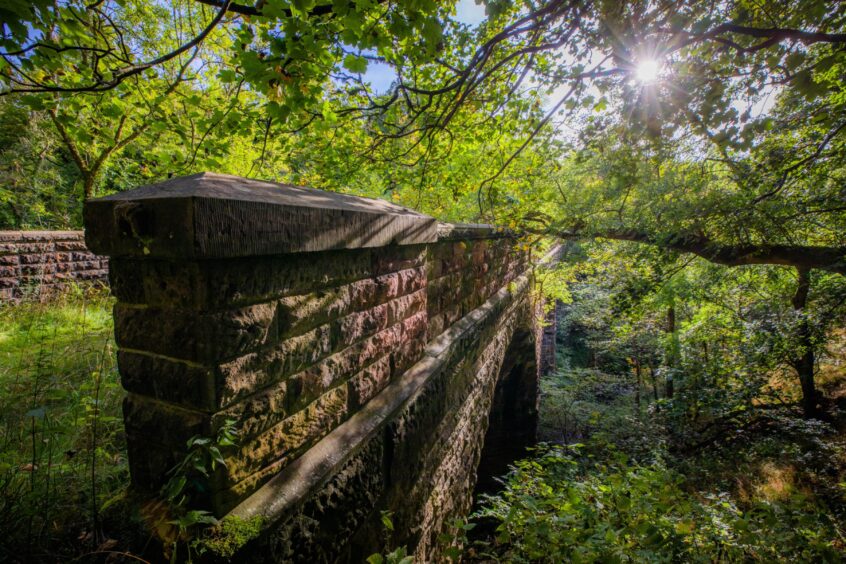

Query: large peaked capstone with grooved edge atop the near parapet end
left=85, top=173, right=437, bottom=259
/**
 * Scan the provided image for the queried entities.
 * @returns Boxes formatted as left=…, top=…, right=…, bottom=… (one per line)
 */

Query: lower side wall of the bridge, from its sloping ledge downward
left=231, top=266, right=532, bottom=563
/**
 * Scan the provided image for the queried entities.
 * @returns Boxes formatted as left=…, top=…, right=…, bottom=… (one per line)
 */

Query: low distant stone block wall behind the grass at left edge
left=0, top=231, right=108, bottom=302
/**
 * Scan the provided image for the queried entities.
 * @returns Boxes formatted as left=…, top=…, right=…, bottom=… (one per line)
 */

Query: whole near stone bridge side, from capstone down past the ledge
left=85, top=173, right=564, bottom=562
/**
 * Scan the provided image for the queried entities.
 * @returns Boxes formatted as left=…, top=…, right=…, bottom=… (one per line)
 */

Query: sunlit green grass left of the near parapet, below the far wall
left=0, top=288, right=128, bottom=561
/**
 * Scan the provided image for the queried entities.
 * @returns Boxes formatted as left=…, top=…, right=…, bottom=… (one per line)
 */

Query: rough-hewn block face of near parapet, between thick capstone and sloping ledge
left=112, top=245, right=434, bottom=514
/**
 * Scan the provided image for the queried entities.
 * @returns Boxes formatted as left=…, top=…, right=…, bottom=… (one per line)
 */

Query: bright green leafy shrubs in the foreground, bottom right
left=479, top=446, right=839, bottom=562
